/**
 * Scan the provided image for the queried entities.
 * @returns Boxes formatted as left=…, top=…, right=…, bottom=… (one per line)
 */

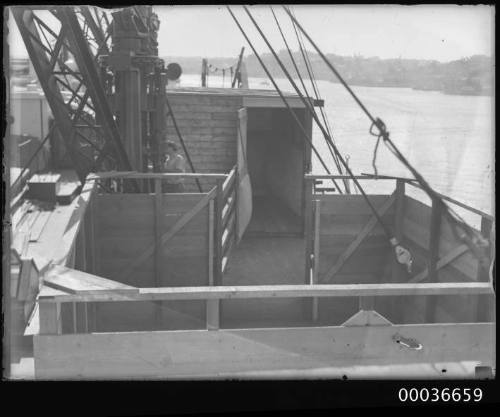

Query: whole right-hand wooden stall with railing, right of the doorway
left=305, top=175, right=494, bottom=324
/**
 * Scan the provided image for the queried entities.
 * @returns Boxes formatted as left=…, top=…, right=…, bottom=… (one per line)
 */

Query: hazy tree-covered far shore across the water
left=165, top=50, right=494, bottom=95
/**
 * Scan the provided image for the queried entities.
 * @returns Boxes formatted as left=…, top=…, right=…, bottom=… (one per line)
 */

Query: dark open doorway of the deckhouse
left=245, top=108, right=305, bottom=236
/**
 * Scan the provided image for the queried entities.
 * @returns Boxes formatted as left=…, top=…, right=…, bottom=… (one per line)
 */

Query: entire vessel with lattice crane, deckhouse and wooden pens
left=5, top=6, right=496, bottom=380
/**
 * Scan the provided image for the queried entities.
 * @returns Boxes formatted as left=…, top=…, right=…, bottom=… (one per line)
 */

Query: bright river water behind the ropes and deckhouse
left=177, top=75, right=495, bottom=214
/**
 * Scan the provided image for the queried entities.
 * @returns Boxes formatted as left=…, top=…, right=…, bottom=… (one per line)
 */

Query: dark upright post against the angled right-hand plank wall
left=426, top=199, right=443, bottom=323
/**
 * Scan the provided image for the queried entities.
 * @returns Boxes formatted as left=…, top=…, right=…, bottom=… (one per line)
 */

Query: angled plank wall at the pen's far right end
left=398, top=196, right=494, bottom=323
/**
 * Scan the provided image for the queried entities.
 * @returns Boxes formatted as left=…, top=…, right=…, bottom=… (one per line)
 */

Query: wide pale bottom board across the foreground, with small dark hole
left=34, top=324, right=495, bottom=379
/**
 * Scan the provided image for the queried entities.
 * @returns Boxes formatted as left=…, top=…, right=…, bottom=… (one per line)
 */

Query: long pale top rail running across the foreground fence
left=39, top=282, right=493, bottom=303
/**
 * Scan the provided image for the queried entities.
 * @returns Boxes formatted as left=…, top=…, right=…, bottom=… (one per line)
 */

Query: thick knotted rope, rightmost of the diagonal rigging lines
left=283, top=6, right=488, bottom=264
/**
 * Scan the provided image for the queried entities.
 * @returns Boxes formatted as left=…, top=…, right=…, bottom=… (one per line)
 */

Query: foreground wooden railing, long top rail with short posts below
left=39, top=283, right=492, bottom=334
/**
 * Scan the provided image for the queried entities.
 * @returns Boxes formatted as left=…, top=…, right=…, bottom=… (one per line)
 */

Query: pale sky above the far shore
left=9, top=5, right=494, bottom=62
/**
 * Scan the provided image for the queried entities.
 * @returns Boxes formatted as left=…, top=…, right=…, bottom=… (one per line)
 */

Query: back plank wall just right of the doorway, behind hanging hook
left=312, top=194, right=395, bottom=324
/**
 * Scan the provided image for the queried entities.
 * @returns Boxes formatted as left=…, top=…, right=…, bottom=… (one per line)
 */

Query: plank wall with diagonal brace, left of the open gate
left=95, top=194, right=209, bottom=331
